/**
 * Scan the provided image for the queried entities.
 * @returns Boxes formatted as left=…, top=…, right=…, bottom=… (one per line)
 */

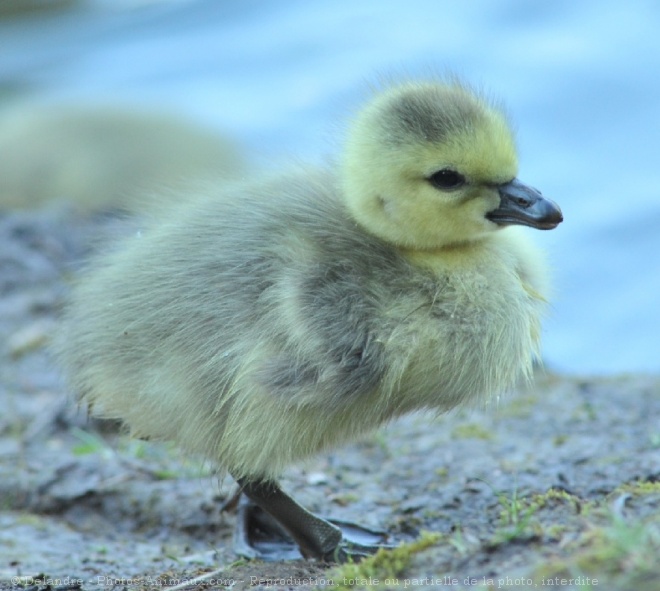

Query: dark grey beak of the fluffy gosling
left=486, top=179, right=564, bottom=230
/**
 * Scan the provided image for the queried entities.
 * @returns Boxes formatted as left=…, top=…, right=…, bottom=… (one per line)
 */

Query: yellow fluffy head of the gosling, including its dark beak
left=342, top=83, right=562, bottom=249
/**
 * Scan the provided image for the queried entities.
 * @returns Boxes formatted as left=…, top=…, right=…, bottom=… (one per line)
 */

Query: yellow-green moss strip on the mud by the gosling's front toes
left=328, top=532, right=442, bottom=591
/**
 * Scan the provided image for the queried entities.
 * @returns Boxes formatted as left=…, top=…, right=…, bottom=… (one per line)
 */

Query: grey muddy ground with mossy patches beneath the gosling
left=0, top=209, right=660, bottom=591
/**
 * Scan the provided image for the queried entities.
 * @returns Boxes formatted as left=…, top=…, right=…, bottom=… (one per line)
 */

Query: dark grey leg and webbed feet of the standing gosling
left=235, top=479, right=386, bottom=562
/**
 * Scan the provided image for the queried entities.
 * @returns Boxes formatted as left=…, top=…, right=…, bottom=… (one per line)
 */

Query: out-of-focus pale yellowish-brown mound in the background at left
left=0, top=104, right=243, bottom=214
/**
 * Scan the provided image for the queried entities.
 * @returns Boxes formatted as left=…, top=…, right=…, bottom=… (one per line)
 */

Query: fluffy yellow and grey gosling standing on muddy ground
left=60, top=81, right=562, bottom=561
